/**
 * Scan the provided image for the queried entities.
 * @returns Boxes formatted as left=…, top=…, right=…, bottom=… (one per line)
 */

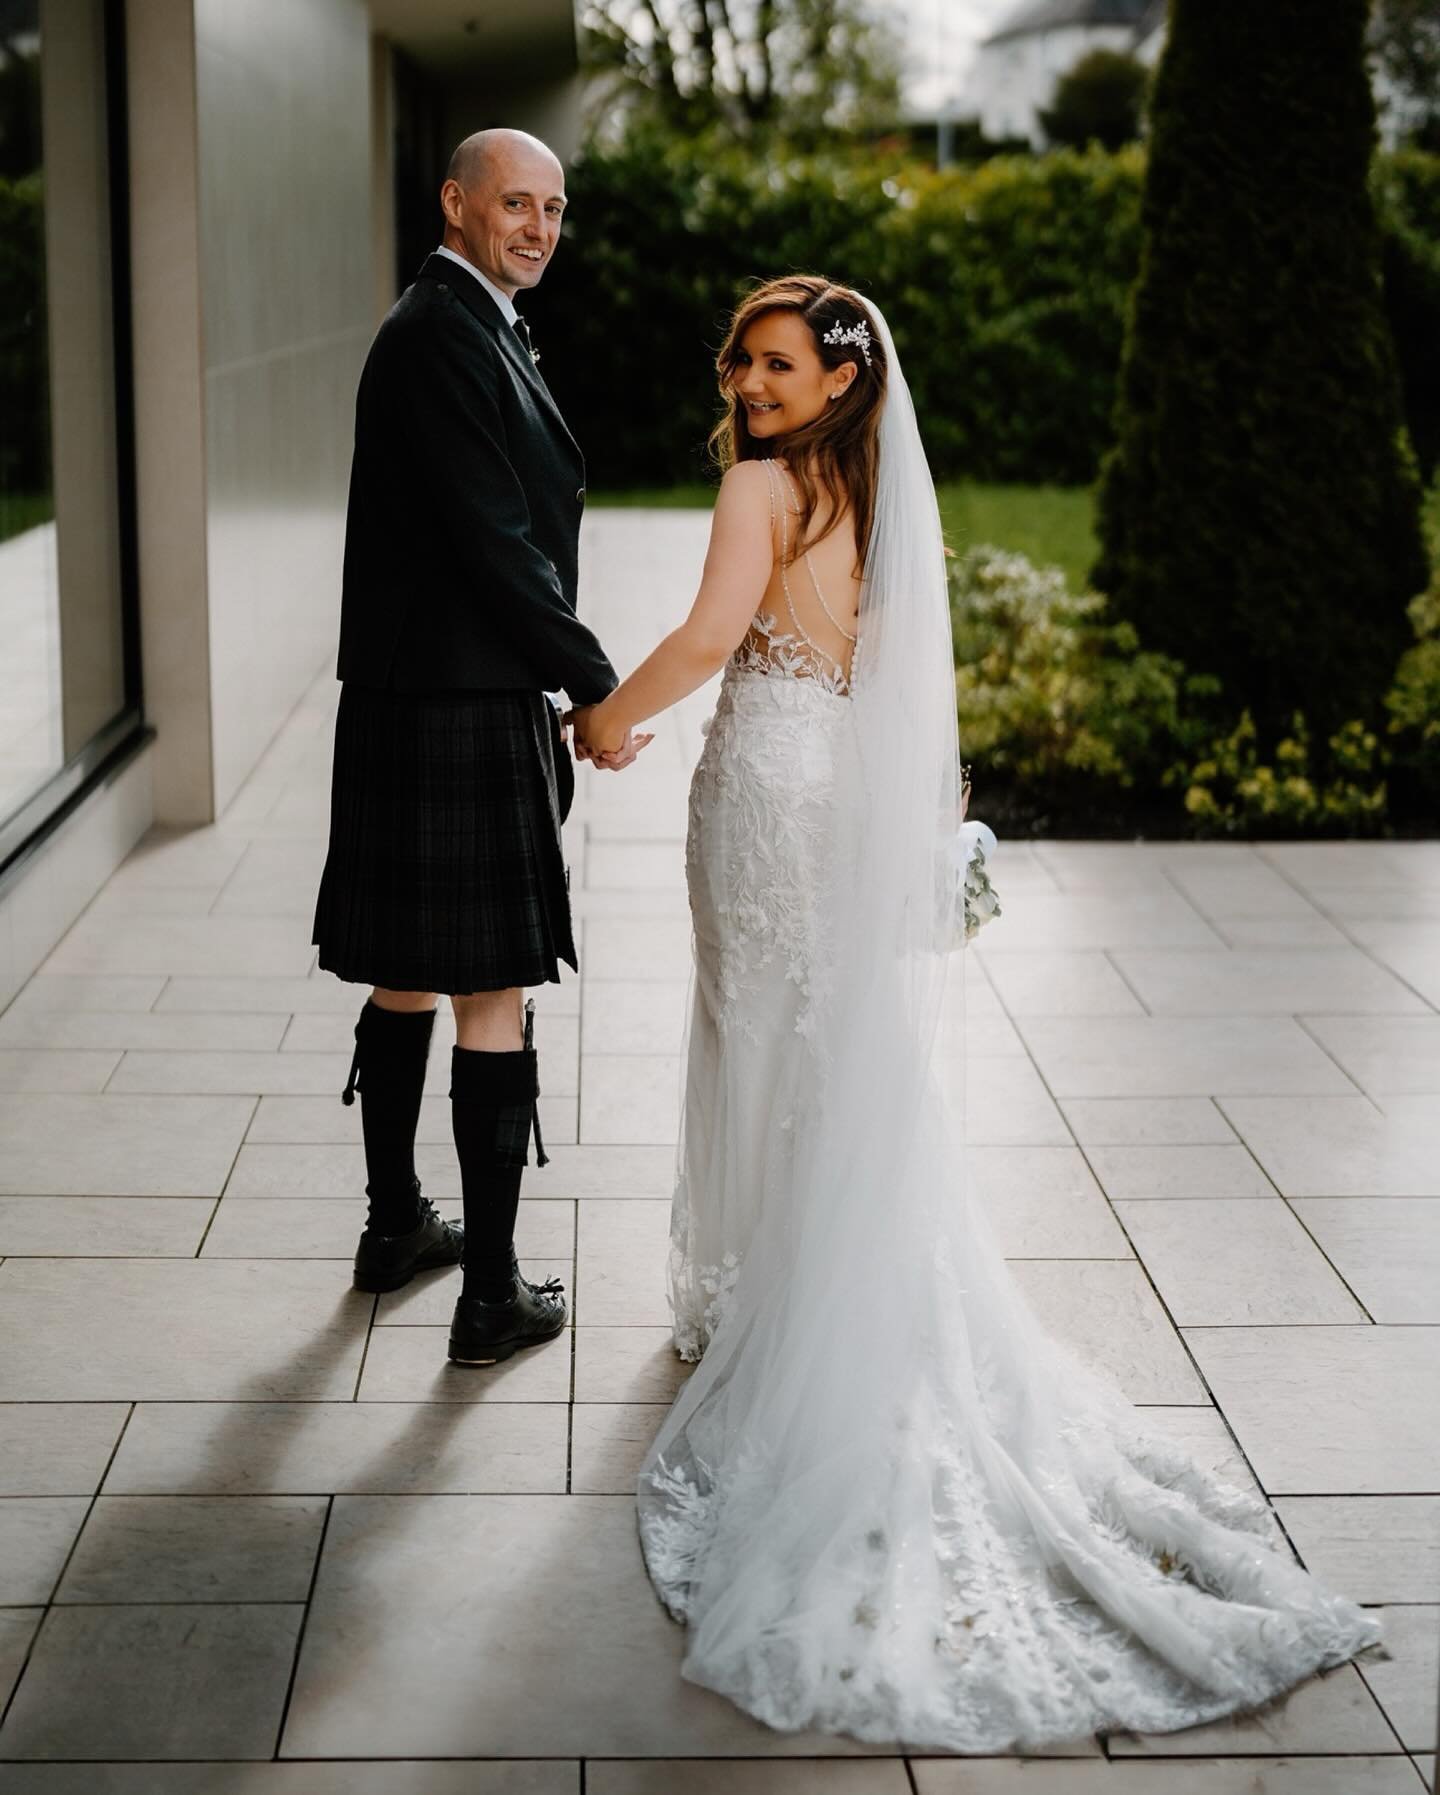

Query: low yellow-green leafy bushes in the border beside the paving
left=952, top=547, right=1407, bottom=836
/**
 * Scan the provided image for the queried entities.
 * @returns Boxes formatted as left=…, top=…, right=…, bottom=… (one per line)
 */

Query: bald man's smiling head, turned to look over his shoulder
left=440, top=129, right=566, bottom=296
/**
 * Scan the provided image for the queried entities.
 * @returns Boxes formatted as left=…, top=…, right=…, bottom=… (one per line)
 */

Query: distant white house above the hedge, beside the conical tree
left=957, top=0, right=1165, bottom=149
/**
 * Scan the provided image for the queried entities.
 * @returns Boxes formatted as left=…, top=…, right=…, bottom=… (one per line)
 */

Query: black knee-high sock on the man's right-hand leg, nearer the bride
left=451, top=1046, right=540, bottom=1303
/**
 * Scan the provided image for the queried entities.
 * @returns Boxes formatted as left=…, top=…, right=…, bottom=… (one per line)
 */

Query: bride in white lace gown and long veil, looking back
left=576, top=276, right=1377, bottom=1752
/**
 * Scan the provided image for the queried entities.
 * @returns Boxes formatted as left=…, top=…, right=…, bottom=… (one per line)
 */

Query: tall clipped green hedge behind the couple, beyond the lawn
left=526, top=138, right=1440, bottom=486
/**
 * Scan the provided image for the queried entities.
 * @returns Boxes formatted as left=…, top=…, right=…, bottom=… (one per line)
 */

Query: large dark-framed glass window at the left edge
left=0, top=0, right=138, bottom=869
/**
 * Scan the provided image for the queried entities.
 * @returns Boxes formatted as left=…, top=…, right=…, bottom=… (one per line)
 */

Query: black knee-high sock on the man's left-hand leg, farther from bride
left=345, top=1003, right=435, bottom=1235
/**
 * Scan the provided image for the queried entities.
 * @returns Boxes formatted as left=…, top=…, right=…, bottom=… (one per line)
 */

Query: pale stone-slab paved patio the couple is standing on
left=0, top=512, right=1440, bottom=1795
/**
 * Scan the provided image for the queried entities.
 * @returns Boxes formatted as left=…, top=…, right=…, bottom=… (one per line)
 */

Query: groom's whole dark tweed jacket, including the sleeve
left=339, top=255, right=616, bottom=704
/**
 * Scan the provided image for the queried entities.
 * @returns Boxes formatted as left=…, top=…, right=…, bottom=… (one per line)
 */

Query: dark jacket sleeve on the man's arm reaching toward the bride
left=388, top=305, right=618, bottom=704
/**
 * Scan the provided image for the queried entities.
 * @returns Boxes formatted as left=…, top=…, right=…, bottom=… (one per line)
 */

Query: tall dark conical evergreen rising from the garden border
left=1093, top=0, right=1427, bottom=734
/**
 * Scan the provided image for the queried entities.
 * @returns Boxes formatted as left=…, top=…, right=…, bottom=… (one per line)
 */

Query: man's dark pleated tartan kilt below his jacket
left=312, top=686, right=576, bottom=993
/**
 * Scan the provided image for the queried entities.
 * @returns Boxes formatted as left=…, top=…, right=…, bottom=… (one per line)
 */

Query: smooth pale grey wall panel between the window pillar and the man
left=196, top=0, right=375, bottom=811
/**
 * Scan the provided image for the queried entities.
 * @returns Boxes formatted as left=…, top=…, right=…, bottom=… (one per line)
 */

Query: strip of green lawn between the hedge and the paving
left=591, top=479, right=1095, bottom=589
